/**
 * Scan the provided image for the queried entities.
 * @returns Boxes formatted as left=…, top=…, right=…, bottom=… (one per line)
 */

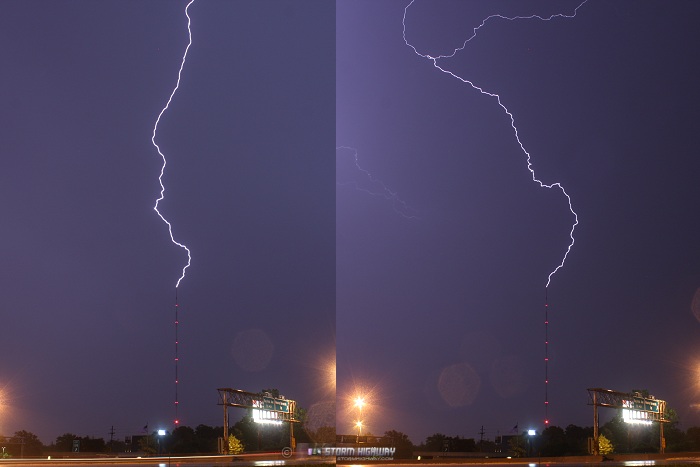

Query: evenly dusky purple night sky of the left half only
left=0, top=0, right=335, bottom=444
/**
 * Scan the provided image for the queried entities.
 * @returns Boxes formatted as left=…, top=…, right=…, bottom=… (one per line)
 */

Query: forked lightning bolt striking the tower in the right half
left=403, top=0, right=588, bottom=289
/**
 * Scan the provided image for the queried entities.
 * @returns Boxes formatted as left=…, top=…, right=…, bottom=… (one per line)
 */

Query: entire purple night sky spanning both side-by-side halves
left=0, top=0, right=700, bottom=454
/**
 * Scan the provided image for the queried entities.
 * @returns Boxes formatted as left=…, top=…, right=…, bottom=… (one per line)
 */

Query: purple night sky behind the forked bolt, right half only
left=336, top=0, right=700, bottom=443
